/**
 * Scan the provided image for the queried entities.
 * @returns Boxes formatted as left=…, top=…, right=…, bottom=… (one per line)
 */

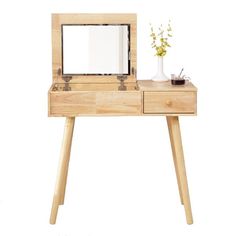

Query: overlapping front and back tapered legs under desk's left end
left=50, top=117, right=75, bottom=224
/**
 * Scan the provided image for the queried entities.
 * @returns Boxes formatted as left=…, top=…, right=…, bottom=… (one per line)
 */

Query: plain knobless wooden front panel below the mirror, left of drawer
left=49, top=91, right=141, bottom=116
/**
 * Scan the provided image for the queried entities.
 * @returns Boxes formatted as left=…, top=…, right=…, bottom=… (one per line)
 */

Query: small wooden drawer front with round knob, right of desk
left=143, top=92, right=197, bottom=114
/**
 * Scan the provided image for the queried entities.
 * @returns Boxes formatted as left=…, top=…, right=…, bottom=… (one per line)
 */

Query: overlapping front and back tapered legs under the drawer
left=166, top=116, right=193, bottom=224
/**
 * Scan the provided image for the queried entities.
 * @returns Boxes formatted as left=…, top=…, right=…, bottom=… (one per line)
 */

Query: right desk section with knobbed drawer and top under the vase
left=140, top=80, right=197, bottom=116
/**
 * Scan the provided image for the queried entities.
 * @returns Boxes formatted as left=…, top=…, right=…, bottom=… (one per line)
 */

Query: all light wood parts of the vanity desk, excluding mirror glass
left=48, top=14, right=197, bottom=224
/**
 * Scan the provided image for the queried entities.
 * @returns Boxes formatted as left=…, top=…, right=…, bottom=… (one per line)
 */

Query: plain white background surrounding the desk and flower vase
left=0, top=0, right=236, bottom=236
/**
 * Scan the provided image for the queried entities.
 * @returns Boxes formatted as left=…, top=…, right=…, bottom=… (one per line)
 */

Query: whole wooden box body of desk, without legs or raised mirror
left=48, top=80, right=197, bottom=116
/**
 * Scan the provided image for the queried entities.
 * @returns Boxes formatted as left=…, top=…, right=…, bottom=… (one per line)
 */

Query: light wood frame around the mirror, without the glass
left=52, top=13, right=137, bottom=83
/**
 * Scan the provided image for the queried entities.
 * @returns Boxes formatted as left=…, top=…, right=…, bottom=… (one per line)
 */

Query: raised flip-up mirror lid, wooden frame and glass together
left=52, top=14, right=136, bottom=83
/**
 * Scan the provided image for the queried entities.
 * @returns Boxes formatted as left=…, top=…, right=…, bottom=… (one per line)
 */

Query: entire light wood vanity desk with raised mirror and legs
left=48, top=14, right=197, bottom=224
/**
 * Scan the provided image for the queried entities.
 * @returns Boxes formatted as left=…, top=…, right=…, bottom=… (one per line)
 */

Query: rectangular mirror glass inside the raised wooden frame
left=62, top=25, right=130, bottom=75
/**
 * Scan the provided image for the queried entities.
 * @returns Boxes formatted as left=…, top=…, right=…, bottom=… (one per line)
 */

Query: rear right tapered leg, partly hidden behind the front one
left=166, top=116, right=184, bottom=204
